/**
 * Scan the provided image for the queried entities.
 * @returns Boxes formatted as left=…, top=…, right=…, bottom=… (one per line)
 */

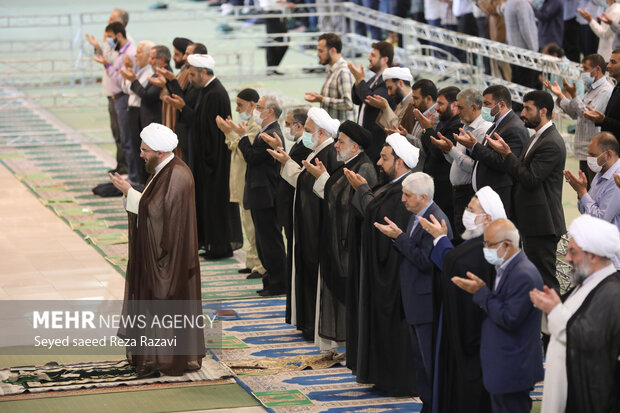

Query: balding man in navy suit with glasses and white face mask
left=452, top=219, right=543, bottom=413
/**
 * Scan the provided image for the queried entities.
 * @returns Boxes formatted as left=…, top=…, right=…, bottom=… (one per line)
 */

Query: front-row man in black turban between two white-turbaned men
left=303, top=120, right=377, bottom=350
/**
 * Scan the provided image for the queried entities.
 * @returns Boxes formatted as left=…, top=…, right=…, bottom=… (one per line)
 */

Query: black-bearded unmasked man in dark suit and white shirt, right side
left=488, top=90, right=566, bottom=292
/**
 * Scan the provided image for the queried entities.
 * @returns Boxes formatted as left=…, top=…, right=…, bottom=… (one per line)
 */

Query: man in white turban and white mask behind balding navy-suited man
left=420, top=186, right=506, bottom=413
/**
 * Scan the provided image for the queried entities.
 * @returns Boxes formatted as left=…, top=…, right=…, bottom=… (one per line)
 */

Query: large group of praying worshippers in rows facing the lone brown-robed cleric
left=89, top=10, right=620, bottom=413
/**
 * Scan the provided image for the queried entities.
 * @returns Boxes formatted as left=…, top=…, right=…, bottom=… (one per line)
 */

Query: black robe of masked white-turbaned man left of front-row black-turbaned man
left=293, top=142, right=340, bottom=340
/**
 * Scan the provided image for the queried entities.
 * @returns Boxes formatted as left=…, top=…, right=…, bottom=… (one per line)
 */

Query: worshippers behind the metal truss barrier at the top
left=217, top=0, right=620, bottom=89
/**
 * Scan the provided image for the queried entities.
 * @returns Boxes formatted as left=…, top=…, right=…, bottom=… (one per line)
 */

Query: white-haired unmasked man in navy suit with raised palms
left=375, top=172, right=452, bottom=412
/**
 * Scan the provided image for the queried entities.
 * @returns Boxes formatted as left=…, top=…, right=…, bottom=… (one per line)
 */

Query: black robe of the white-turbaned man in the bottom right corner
left=566, top=272, right=620, bottom=413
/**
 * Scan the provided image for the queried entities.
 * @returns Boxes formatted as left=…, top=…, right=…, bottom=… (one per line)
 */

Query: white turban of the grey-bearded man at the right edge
left=568, top=215, right=620, bottom=258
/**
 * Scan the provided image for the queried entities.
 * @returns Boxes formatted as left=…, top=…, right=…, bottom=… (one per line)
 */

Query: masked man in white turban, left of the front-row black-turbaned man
left=261, top=104, right=342, bottom=340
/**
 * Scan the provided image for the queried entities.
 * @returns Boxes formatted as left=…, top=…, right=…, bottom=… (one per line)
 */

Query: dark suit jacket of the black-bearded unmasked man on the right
left=504, top=125, right=566, bottom=237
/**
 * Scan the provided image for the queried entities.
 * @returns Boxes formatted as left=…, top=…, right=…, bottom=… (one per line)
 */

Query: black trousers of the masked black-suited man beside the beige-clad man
left=250, top=208, right=286, bottom=293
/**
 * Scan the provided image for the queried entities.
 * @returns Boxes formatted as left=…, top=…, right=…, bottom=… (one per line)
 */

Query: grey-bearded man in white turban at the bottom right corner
left=530, top=215, right=620, bottom=413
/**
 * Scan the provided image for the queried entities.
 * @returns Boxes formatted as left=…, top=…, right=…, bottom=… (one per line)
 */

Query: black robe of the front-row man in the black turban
left=319, top=152, right=377, bottom=342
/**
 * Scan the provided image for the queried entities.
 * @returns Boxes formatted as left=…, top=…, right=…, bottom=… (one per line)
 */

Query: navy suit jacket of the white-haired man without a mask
left=394, top=202, right=452, bottom=324
